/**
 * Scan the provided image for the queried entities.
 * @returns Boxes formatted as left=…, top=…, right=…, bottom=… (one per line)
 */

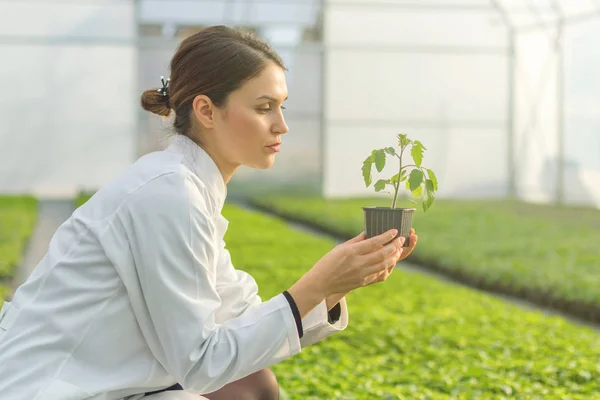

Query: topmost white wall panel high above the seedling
left=324, top=3, right=506, bottom=46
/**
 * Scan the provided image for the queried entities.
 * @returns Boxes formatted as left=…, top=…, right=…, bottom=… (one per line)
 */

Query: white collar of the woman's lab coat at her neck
left=169, top=134, right=227, bottom=212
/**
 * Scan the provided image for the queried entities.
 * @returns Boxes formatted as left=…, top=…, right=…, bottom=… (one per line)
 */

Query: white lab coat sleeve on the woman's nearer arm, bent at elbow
left=113, top=173, right=301, bottom=394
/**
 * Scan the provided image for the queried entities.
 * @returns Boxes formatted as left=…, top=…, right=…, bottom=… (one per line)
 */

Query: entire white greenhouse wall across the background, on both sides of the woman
left=0, top=0, right=600, bottom=206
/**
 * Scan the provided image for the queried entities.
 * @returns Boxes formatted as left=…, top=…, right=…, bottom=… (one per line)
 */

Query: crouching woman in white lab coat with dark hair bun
left=0, top=26, right=417, bottom=400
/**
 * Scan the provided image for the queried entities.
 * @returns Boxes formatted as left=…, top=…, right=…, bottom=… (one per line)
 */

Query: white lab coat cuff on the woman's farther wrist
left=300, top=297, right=348, bottom=348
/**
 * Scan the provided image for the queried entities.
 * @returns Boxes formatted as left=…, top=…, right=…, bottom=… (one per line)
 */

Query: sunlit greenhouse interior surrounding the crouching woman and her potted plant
left=0, top=0, right=600, bottom=400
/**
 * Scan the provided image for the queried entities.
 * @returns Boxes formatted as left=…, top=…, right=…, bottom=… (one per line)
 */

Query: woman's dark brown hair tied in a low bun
left=141, top=25, right=286, bottom=135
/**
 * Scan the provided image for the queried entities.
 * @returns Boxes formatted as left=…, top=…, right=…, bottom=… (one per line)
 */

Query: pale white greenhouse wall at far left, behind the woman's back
left=0, top=0, right=137, bottom=196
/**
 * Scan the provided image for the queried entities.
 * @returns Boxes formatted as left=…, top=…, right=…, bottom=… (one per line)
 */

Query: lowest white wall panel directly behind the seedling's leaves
left=324, top=124, right=507, bottom=198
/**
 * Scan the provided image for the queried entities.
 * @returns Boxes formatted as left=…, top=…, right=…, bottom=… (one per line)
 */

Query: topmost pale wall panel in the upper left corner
left=0, top=0, right=135, bottom=39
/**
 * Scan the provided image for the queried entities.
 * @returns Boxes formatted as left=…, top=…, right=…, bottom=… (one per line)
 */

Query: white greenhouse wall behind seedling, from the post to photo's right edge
left=323, top=0, right=600, bottom=206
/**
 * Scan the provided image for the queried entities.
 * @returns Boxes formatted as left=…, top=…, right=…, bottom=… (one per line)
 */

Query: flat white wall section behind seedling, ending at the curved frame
left=323, top=1, right=507, bottom=197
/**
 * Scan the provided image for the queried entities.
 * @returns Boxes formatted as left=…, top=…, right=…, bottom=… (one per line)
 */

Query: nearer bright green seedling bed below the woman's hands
left=224, top=205, right=600, bottom=399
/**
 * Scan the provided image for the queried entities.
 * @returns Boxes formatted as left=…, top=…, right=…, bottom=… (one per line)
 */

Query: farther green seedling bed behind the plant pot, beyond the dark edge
left=243, top=196, right=600, bottom=323
